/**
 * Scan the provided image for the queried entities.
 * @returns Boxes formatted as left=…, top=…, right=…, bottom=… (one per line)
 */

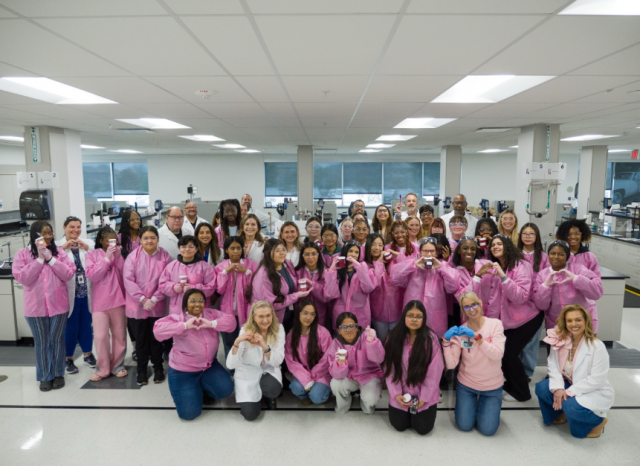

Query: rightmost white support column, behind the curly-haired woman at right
left=577, top=146, right=609, bottom=219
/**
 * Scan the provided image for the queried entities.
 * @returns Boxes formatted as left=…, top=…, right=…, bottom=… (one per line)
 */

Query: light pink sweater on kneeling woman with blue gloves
left=443, top=317, right=506, bottom=391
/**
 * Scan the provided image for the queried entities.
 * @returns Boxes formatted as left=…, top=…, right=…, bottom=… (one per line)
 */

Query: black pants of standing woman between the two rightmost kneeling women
left=502, top=312, right=544, bottom=401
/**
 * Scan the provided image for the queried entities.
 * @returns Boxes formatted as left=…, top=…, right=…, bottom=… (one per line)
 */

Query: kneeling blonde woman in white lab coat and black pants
left=227, top=301, right=285, bottom=421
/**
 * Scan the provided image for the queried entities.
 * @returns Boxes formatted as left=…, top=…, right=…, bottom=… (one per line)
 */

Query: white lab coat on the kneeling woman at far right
left=547, top=340, right=614, bottom=417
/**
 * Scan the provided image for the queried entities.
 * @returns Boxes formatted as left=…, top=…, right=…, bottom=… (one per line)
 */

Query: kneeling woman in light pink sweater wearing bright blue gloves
left=442, top=291, right=505, bottom=436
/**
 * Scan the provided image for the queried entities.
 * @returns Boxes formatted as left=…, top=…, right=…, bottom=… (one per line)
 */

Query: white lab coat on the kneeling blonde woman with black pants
left=227, top=324, right=285, bottom=403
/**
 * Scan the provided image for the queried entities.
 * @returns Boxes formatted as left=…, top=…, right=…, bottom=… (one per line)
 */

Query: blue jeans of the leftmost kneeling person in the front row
left=169, top=359, right=233, bottom=421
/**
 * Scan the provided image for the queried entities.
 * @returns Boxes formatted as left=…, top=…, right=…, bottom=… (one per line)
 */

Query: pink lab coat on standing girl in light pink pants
left=85, top=249, right=126, bottom=313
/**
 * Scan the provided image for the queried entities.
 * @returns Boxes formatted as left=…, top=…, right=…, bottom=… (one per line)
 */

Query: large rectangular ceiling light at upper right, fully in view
left=431, top=74, right=555, bottom=104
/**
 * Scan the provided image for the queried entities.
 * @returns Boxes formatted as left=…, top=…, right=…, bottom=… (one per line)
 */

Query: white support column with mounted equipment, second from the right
left=515, top=124, right=560, bottom=243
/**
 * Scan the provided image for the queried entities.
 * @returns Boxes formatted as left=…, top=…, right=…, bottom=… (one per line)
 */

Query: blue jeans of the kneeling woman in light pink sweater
left=455, top=381, right=502, bottom=436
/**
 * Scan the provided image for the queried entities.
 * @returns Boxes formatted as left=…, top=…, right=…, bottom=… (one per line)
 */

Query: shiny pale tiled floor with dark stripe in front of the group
left=0, top=309, right=640, bottom=466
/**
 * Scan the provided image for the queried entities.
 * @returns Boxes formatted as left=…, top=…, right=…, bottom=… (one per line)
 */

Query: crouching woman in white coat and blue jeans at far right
left=536, top=304, right=614, bottom=438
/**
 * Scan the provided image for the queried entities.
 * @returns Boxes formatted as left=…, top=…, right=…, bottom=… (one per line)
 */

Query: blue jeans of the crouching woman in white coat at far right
left=536, top=379, right=604, bottom=438
